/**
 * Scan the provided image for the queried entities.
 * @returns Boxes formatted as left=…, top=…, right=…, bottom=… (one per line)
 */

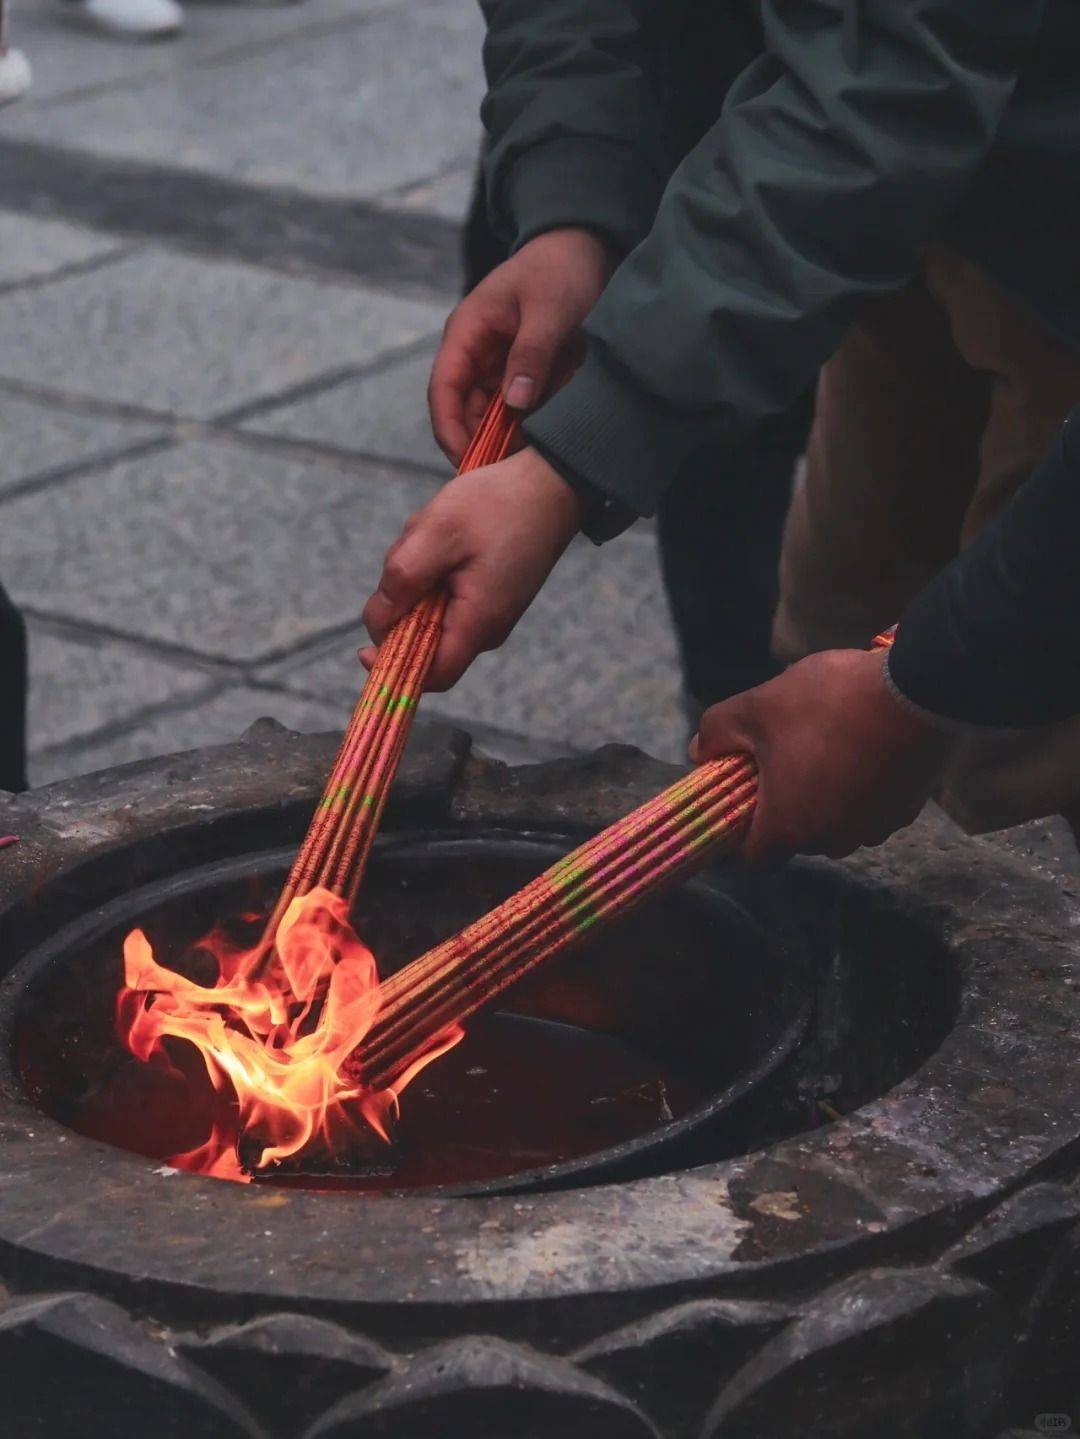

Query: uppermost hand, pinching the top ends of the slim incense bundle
left=427, top=229, right=615, bottom=465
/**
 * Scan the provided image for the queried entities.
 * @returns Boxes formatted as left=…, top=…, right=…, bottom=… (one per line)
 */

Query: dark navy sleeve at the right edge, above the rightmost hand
left=887, top=410, right=1080, bottom=725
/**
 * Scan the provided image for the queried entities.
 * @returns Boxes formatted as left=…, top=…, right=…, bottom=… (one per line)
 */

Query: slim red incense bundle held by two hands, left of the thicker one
left=263, top=397, right=516, bottom=954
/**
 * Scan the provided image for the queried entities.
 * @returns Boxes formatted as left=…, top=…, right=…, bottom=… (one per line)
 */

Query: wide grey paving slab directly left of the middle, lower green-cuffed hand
left=0, top=442, right=440, bottom=662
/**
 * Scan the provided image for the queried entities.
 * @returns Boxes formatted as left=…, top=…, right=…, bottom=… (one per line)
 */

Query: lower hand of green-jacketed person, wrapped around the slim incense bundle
left=360, top=449, right=581, bottom=689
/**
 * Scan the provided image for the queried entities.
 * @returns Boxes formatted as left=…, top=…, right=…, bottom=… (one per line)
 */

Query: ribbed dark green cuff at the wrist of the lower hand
left=522, top=344, right=723, bottom=515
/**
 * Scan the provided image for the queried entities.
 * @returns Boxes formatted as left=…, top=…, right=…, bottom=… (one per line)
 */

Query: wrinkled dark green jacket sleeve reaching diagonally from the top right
left=525, top=0, right=1044, bottom=514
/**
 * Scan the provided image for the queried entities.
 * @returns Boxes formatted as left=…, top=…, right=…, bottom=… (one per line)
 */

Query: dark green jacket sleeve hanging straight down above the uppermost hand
left=480, top=0, right=673, bottom=253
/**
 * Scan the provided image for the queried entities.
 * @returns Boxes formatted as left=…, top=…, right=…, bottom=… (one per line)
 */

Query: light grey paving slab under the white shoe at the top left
left=7, top=0, right=384, bottom=106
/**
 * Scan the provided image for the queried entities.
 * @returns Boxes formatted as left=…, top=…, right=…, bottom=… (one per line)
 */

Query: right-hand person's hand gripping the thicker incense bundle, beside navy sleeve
left=690, top=649, right=951, bottom=862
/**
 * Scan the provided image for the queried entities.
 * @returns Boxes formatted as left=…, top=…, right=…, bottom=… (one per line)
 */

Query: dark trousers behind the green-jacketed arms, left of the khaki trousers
left=463, top=174, right=813, bottom=709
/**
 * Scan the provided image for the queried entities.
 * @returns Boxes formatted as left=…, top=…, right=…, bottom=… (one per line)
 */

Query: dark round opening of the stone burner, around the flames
left=0, top=836, right=955, bottom=1194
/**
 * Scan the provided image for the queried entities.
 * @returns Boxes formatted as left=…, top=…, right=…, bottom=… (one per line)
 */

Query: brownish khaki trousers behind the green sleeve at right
left=772, top=249, right=1080, bottom=832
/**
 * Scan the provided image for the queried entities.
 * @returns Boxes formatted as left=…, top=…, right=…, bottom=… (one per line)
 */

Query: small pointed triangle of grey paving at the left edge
left=0, top=394, right=161, bottom=495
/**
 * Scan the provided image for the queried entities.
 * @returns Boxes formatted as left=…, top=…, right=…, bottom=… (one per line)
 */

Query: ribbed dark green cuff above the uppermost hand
left=488, top=137, right=664, bottom=255
